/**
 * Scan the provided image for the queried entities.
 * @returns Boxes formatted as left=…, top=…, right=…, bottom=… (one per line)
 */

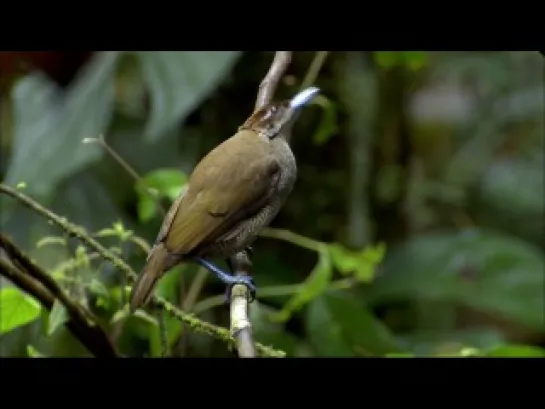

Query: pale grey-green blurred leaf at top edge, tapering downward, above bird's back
left=136, top=51, right=240, bottom=139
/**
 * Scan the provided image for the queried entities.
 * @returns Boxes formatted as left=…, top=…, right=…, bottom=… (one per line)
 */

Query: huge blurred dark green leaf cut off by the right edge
left=369, top=230, right=545, bottom=330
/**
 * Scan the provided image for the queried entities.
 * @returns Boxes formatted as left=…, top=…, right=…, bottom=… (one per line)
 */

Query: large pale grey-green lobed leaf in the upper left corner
left=6, top=52, right=118, bottom=197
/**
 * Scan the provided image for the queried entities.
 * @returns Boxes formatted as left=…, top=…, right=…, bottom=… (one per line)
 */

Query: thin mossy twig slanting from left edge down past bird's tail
left=0, top=183, right=285, bottom=358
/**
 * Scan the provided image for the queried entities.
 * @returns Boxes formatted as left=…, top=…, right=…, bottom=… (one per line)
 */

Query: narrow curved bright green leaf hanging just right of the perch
left=272, top=246, right=333, bottom=322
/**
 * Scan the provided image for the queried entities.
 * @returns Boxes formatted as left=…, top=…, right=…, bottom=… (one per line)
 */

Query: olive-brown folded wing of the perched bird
left=158, top=134, right=280, bottom=255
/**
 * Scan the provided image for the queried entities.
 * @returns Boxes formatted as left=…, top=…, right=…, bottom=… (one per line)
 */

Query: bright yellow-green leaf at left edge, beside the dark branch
left=0, top=287, right=41, bottom=334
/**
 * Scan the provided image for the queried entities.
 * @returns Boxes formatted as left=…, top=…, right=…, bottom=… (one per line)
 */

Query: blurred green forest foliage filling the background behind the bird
left=0, top=51, right=545, bottom=357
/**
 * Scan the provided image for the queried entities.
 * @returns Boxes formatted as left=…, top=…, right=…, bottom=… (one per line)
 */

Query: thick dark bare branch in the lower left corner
left=0, top=234, right=117, bottom=358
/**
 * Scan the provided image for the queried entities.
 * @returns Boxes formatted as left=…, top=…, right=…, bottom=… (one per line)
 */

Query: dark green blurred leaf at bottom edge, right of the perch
left=307, top=292, right=401, bottom=355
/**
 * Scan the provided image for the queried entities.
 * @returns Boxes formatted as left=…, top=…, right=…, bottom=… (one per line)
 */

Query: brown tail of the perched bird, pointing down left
left=130, top=243, right=170, bottom=313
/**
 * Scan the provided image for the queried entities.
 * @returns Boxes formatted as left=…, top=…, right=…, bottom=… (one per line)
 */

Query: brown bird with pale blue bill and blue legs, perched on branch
left=130, top=87, right=319, bottom=311
